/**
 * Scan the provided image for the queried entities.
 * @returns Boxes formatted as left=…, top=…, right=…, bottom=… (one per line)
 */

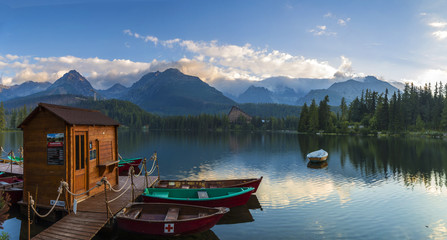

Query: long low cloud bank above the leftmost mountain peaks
left=0, top=54, right=152, bottom=89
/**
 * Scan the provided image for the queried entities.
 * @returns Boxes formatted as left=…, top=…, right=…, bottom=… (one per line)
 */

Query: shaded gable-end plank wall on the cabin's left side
left=23, top=109, right=68, bottom=205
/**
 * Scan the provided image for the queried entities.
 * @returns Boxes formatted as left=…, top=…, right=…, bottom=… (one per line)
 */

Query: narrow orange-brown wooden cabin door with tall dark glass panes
left=74, top=132, right=88, bottom=193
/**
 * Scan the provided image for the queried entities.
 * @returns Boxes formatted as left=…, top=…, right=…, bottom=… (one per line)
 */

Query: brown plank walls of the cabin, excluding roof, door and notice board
left=23, top=108, right=118, bottom=206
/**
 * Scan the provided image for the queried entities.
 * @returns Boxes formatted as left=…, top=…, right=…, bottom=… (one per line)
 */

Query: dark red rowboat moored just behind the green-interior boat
left=155, top=177, right=262, bottom=193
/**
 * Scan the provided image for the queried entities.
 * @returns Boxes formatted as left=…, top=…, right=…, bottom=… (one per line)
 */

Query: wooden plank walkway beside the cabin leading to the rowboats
left=33, top=176, right=157, bottom=240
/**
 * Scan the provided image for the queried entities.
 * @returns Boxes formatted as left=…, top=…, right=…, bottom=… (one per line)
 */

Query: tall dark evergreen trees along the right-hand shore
left=298, top=82, right=447, bottom=133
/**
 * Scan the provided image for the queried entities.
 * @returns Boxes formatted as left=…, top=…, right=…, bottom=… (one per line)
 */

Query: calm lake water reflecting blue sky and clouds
left=0, top=131, right=447, bottom=240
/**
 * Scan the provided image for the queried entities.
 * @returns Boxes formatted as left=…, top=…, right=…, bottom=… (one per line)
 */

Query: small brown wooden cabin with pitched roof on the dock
left=19, top=103, right=119, bottom=207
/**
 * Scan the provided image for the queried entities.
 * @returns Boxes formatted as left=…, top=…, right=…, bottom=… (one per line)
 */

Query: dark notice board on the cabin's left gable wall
left=47, top=133, right=65, bottom=165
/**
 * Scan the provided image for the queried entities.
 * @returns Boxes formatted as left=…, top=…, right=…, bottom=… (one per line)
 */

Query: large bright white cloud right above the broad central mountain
left=128, top=30, right=350, bottom=81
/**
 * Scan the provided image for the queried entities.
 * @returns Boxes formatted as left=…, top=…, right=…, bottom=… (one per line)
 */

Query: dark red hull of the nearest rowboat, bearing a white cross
left=116, top=205, right=228, bottom=236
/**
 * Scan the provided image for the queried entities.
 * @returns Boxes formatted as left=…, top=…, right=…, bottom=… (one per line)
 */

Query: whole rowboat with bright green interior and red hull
left=142, top=187, right=254, bottom=208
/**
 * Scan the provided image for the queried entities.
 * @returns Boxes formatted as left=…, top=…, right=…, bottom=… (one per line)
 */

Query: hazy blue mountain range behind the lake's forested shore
left=0, top=68, right=397, bottom=115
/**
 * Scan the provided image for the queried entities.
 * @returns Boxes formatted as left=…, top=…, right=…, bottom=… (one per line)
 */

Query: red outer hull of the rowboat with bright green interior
left=142, top=189, right=254, bottom=208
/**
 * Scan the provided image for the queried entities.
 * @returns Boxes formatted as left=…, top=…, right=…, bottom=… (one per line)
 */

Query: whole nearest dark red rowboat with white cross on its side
left=116, top=203, right=229, bottom=236
